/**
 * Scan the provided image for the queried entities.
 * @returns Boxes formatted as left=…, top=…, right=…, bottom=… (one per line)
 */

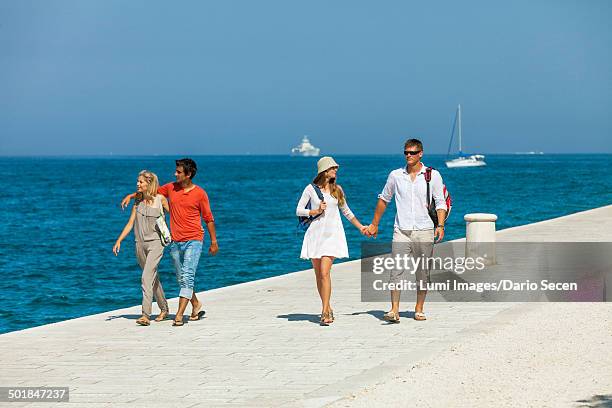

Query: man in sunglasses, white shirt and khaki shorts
left=367, top=139, right=446, bottom=323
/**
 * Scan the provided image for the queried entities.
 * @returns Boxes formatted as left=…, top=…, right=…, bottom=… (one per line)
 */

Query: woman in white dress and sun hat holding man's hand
left=296, top=157, right=367, bottom=326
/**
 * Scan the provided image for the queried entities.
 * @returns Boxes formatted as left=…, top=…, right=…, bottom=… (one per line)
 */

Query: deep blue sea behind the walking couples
left=0, top=154, right=612, bottom=333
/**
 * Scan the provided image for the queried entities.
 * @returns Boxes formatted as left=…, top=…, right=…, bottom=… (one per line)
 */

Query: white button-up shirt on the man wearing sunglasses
left=378, top=163, right=446, bottom=230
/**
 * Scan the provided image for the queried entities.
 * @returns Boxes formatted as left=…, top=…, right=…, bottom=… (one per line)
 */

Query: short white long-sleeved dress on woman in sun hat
left=296, top=184, right=355, bottom=259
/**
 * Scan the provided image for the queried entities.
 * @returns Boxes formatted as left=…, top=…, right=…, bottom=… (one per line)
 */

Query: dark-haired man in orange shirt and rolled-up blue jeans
left=121, top=158, right=219, bottom=326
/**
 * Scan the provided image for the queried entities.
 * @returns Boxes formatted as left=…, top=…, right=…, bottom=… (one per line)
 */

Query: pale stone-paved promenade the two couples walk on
left=0, top=206, right=612, bottom=408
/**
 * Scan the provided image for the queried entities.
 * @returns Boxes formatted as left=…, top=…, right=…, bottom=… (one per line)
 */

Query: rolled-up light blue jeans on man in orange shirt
left=170, top=241, right=202, bottom=299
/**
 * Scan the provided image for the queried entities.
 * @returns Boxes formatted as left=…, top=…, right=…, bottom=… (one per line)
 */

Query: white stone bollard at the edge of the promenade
left=463, top=213, right=497, bottom=265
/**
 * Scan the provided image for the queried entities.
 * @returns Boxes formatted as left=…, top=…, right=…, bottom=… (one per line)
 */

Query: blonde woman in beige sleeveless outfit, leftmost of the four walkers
left=113, top=170, right=168, bottom=326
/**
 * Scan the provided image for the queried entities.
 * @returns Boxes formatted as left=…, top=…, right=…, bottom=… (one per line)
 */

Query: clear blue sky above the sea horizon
left=0, top=0, right=612, bottom=155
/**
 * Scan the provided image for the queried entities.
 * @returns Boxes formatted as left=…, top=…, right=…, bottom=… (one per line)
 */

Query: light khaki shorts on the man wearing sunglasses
left=389, top=228, right=434, bottom=287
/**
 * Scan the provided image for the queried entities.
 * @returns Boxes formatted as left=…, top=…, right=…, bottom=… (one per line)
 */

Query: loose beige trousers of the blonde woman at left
left=136, top=239, right=168, bottom=316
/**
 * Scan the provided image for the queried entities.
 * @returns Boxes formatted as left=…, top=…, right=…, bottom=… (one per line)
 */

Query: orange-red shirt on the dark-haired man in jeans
left=157, top=183, right=214, bottom=242
